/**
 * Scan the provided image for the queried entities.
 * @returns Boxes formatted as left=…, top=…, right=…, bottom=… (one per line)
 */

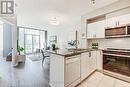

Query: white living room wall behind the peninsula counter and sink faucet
left=48, top=20, right=81, bottom=49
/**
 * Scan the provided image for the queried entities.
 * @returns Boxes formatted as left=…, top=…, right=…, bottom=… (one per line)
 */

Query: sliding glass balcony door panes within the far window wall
left=25, top=34, right=40, bottom=54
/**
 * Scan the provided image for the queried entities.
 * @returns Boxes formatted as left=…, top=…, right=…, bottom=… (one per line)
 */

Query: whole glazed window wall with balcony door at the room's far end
left=18, top=27, right=47, bottom=54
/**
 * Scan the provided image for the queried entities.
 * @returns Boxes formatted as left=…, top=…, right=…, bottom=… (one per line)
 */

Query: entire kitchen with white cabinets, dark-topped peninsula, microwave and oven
left=50, top=2, right=130, bottom=87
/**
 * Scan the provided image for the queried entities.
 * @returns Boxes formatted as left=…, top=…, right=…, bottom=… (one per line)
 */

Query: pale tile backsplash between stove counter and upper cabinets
left=88, top=38, right=130, bottom=49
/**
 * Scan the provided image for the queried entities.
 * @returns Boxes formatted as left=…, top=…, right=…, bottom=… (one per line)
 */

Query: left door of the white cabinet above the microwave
left=106, top=17, right=117, bottom=28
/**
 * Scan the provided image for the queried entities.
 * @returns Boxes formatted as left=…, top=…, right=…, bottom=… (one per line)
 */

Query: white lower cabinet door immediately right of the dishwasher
left=81, top=51, right=97, bottom=80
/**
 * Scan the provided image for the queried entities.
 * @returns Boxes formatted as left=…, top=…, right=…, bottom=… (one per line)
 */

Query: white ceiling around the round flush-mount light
left=16, top=0, right=118, bottom=28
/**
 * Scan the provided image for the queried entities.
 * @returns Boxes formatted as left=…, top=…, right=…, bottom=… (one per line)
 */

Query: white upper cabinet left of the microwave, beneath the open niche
left=87, top=20, right=105, bottom=39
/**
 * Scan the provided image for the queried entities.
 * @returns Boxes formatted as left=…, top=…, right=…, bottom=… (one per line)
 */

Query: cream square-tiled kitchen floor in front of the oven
left=78, top=72, right=130, bottom=87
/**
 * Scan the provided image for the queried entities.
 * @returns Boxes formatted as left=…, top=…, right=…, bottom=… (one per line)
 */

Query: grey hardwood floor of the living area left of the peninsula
left=0, top=59, right=50, bottom=87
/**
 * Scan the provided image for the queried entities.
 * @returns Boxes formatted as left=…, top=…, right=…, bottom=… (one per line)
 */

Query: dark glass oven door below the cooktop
left=103, top=54, right=130, bottom=76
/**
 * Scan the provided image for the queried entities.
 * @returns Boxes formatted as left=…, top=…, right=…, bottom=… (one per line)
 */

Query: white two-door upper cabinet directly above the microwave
left=106, top=8, right=130, bottom=28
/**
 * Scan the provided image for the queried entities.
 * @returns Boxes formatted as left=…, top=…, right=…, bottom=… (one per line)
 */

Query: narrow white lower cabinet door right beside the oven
left=97, top=51, right=103, bottom=71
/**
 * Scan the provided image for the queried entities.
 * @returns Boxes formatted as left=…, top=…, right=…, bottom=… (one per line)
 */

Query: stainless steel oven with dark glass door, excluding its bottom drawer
left=103, top=48, right=130, bottom=76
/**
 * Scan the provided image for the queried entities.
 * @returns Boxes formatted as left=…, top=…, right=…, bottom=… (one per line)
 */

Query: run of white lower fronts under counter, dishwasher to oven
left=65, top=51, right=102, bottom=87
